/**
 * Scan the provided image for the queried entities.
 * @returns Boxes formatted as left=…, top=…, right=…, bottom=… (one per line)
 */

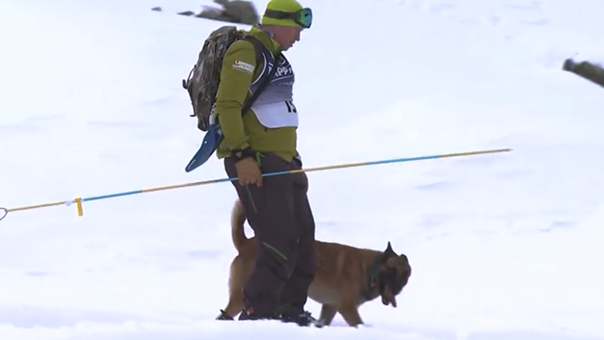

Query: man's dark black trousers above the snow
left=224, top=153, right=316, bottom=317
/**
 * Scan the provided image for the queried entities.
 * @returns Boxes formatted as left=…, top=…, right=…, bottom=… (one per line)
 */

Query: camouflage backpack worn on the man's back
left=182, top=26, right=263, bottom=131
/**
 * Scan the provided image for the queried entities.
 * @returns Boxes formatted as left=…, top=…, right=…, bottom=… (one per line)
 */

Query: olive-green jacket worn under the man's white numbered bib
left=216, top=27, right=298, bottom=162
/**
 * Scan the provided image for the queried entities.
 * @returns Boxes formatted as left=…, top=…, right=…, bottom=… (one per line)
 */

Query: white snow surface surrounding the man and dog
left=0, top=0, right=604, bottom=340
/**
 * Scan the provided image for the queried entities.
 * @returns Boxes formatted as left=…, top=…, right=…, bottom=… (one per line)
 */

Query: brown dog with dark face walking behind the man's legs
left=217, top=200, right=411, bottom=327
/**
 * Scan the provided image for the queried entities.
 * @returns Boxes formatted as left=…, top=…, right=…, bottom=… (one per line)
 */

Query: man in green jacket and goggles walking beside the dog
left=216, top=0, right=315, bottom=325
